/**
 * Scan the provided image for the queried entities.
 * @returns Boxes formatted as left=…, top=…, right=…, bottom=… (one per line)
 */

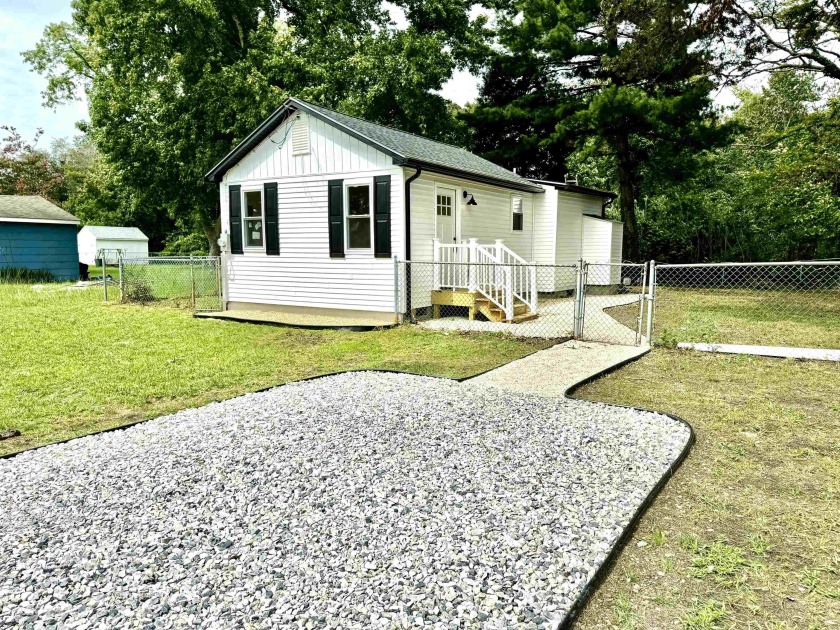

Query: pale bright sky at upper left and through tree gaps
left=0, top=0, right=734, bottom=148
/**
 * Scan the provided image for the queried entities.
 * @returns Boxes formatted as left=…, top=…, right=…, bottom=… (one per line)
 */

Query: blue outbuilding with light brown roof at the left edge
left=0, top=195, right=79, bottom=280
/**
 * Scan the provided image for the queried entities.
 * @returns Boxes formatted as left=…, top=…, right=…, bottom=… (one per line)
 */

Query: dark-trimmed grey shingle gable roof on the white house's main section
left=205, top=98, right=544, bottom=193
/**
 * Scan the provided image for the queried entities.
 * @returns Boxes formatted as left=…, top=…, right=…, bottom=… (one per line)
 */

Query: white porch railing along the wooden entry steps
left=434, top=238, right=537, bottom=320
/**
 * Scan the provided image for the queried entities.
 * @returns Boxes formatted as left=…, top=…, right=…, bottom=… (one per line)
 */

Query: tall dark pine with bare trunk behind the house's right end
left=469, top=0, right=721, bottom=258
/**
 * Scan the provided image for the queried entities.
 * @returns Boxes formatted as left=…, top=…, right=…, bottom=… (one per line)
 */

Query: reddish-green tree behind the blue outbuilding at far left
left=0, top=126, right=64, bottom=203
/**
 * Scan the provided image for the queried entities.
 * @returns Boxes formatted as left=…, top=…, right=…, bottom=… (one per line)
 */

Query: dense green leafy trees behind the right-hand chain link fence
left=616, top=71, right=840, bottom=262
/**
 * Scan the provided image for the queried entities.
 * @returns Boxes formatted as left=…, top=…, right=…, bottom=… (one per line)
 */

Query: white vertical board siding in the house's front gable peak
left=225, top=114, right=393, bottom=183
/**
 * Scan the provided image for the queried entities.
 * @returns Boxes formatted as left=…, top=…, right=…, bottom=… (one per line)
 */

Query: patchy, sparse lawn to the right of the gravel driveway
left=576, top=345, right=840, bottom=630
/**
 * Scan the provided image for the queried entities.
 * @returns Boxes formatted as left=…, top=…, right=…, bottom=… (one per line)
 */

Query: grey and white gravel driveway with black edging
left=0, top=373, right=689, bottom=628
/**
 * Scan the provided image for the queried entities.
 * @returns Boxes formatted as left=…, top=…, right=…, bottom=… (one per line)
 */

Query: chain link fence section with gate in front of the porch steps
left=394, top=262, right=646, bottom=345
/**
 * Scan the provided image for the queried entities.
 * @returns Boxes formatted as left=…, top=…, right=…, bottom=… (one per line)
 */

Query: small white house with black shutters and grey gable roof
left=206, top=98, right=620, bottom=323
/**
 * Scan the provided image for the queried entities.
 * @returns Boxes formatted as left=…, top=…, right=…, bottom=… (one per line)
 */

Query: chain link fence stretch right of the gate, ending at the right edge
left=653, top=261, right=840, bottom=349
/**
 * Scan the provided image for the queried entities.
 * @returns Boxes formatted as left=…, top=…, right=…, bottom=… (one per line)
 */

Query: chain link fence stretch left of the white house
left=119, top=256, right=222, bottom=311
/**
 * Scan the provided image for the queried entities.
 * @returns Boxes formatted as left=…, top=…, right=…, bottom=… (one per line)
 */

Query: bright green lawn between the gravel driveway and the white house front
left=0, top=285, right=546, bottom=454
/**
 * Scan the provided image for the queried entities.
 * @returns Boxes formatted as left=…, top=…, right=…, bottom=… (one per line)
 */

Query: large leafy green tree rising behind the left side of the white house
left=25, top=0, right=483, bottom=251
